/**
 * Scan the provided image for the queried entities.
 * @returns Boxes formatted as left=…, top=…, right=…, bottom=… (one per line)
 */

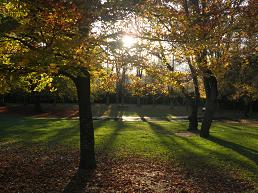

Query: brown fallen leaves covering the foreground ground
left=0, top=145, right=255, bottom=193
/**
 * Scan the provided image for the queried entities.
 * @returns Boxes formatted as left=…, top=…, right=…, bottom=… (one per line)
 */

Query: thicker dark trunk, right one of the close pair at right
left=200, top=71, right=218, bottom=138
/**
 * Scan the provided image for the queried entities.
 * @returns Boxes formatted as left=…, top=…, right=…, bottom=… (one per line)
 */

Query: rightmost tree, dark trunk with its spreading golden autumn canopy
left=139, top=0, right=252, bottom=137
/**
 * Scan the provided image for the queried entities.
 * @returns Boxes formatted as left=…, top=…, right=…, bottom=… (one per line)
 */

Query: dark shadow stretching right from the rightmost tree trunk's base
left=208, top=136, right=258, bottom=165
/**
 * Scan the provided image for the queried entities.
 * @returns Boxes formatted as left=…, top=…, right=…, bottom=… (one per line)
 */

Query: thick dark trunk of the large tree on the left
left=74, top=75, right=96, bottom=169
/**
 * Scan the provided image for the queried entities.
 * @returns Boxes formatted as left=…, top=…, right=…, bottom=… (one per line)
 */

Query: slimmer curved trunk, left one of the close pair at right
left=188, top=61, right=200, bottom=131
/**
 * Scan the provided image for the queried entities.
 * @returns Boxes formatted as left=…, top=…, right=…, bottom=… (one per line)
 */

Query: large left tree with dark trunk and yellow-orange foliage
left=1, top=0, right=143, bottom=169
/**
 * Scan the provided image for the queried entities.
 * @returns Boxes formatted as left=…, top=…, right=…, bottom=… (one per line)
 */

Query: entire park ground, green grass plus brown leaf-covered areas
left=0, top=105, right=258, bottom=193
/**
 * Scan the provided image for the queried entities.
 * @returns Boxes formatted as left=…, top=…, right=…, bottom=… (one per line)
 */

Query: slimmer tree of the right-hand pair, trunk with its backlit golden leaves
left=133, top=1, right=204, bottom=130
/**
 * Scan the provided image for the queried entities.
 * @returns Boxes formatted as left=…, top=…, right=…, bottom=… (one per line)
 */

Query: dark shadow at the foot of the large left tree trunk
left=63, top=169, right=95, bottom=193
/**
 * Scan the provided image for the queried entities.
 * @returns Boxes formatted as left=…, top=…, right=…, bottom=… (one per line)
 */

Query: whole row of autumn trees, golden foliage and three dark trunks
left=0, top=0, right=258, bottom=169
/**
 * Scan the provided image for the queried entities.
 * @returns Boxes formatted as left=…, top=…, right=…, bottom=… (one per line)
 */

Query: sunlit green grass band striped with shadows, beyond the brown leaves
left=0, top=116, right=258, bottom=185
